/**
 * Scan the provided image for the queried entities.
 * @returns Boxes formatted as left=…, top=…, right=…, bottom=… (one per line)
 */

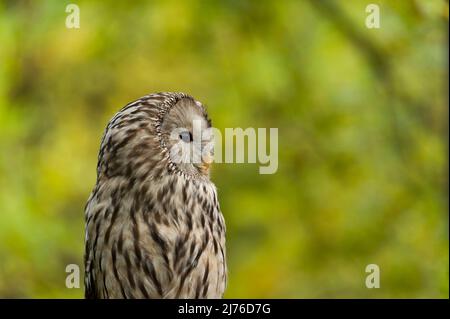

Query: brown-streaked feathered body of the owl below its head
left=85, top=179, right=226, bottom=298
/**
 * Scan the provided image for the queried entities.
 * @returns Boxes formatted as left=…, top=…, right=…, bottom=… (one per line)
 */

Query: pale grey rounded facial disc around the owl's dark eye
left=161, top=98, right=213, bottom=176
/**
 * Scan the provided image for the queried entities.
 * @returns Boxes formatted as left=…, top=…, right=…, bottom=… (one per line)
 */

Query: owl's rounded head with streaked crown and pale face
left=97, top=92, right=213, bottom=182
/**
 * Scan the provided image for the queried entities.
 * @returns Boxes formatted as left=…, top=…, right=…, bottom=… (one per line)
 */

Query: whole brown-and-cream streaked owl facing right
left=84, top=93, right=227, bottom=299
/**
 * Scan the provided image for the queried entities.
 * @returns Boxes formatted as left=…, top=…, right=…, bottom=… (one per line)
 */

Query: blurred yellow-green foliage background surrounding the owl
left=0, top=0, right=449, bottom=298
